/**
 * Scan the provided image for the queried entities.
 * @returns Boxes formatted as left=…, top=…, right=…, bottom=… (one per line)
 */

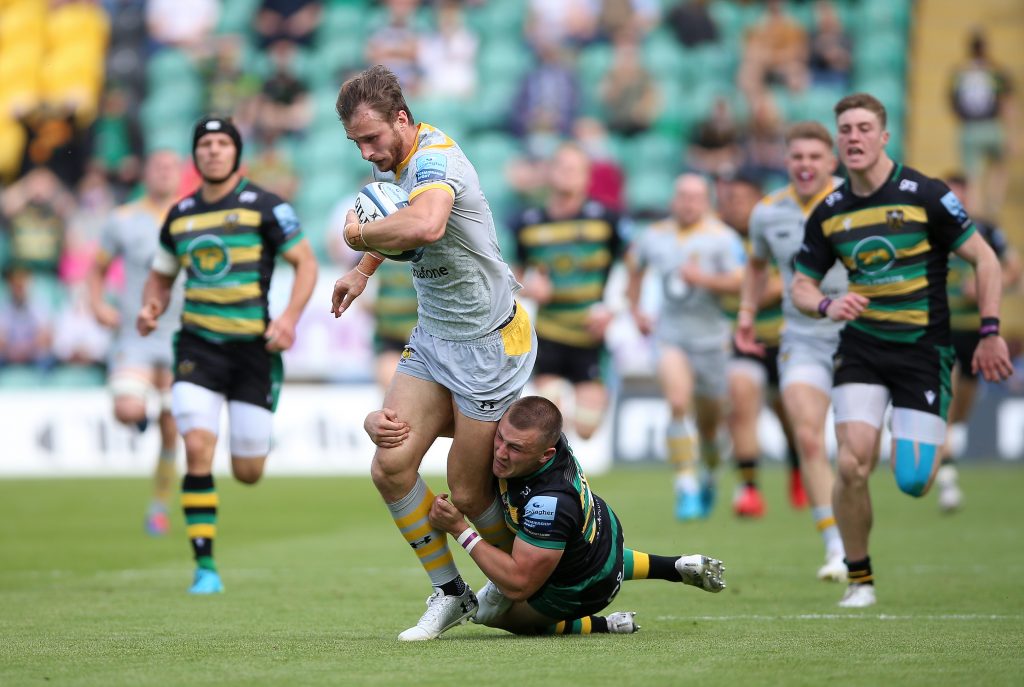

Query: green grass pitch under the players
left=0, top=466, right=1024, bottom=687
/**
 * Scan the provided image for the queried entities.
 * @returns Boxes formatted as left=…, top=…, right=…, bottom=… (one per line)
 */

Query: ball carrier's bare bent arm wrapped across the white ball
left=345, top=182, right=455, bottom=251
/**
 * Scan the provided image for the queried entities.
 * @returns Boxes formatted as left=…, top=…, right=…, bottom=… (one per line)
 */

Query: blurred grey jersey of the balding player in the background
left=633, top=217, right=745, bottom=350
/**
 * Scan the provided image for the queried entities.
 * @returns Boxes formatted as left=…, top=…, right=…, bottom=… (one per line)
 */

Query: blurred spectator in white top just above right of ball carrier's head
left=419, top=0, right=478, bottom=99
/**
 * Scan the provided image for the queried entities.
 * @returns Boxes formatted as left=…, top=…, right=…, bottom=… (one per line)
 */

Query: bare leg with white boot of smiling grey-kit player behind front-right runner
left=782, top=380, right=847, bottom=582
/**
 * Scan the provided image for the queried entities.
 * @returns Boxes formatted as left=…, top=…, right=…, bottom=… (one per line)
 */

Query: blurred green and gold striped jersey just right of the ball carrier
left=513, top=201, right=626, bottom=348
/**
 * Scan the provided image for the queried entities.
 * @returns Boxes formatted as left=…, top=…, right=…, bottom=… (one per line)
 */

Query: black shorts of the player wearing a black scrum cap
left=174, top=330, right=285, bottom=411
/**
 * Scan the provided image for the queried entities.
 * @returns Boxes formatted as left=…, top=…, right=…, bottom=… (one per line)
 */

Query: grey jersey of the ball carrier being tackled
left=374, top=123, right=522, bottom=341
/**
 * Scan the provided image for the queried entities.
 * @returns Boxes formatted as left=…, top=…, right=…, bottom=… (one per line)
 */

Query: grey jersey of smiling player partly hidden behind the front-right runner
left=751, top=178, right=848, bottom=338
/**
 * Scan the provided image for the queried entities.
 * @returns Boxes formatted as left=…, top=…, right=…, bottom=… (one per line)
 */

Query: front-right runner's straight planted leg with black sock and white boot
left=833, top=380, right=889, bottom=607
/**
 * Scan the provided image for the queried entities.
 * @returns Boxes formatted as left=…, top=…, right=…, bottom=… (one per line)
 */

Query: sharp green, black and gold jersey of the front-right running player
left=797, top=165, right=975, bottom=344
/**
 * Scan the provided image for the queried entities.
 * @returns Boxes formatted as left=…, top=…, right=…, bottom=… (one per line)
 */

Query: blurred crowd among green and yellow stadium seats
left=0, top=0, right=1011, bottom=387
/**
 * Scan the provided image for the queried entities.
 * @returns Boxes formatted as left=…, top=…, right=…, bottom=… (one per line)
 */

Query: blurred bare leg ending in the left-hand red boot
left=728, top=357, right=766, bottom=518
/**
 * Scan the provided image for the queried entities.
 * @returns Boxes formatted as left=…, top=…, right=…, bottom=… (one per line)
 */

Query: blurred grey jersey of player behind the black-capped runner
left=99, top=200, right=184, bottom=346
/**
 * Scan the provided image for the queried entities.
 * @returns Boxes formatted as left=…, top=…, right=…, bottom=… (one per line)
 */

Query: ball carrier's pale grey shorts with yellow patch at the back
left=397, top=307, right=537, bottom=422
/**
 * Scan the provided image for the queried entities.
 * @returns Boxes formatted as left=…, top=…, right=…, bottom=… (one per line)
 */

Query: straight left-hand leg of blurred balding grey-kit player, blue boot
left=657, top=344, right=705, bottom=520
